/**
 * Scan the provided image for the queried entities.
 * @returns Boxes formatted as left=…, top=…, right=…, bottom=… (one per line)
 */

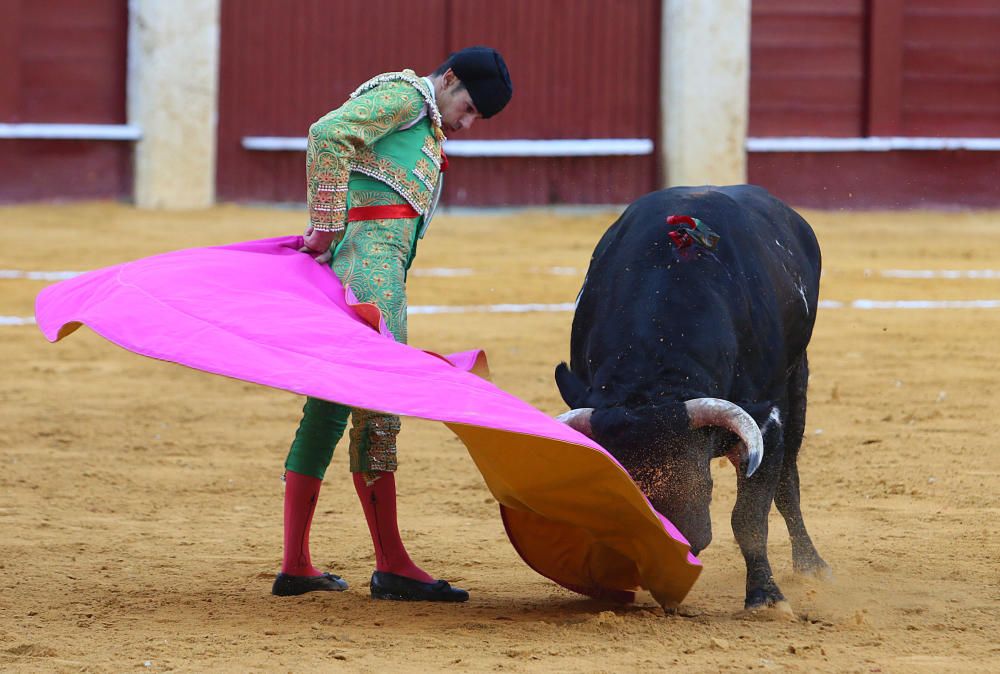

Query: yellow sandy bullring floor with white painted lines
left=0, top=204, right=1000, bottom=672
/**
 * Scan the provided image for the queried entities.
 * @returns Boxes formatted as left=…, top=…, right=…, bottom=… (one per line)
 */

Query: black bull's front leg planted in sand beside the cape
left=732, top=456, right=791, bottom=612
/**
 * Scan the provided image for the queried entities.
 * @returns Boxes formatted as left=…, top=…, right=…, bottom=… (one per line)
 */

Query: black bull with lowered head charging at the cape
left=556, top=185, right=828, bottom=608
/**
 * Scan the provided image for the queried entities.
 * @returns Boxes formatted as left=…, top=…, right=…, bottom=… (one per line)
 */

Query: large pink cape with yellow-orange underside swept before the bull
left=35, top=237, right=701, bottom=608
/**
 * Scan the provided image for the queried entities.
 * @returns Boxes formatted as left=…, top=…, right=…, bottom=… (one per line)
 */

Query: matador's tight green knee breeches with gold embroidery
left=285, top=181, right=420, bottom=480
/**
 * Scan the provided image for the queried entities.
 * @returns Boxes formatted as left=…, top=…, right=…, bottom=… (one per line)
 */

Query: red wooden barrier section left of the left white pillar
left=0, top=0, right=132, bottom=202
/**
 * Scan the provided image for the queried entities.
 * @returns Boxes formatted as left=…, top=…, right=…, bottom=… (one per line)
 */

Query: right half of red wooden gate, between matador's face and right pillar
left=443, top=0, right=660, bottom=206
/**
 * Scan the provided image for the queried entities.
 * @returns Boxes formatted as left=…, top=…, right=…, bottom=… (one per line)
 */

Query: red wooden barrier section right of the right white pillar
left=747, top=0, right=1000, bottom=208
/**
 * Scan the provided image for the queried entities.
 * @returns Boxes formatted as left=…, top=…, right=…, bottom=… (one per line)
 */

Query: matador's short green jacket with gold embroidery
left=306, top=70, right=444, bottom=233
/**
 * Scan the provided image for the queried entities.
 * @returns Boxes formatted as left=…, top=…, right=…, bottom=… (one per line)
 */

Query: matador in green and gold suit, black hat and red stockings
left=271, top=47, right=513, bottom=602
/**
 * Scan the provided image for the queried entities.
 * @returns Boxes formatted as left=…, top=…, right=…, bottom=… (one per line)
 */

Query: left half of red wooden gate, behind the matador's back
left=217, top=0, right=446, bottom=202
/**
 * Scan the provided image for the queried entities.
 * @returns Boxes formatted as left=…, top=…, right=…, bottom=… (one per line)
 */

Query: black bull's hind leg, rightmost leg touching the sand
left=774, top=354, right=830, bottom=576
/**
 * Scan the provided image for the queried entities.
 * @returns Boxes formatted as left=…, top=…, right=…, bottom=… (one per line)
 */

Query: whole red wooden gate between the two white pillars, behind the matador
left=218, top=0, right=660, bottom=205
